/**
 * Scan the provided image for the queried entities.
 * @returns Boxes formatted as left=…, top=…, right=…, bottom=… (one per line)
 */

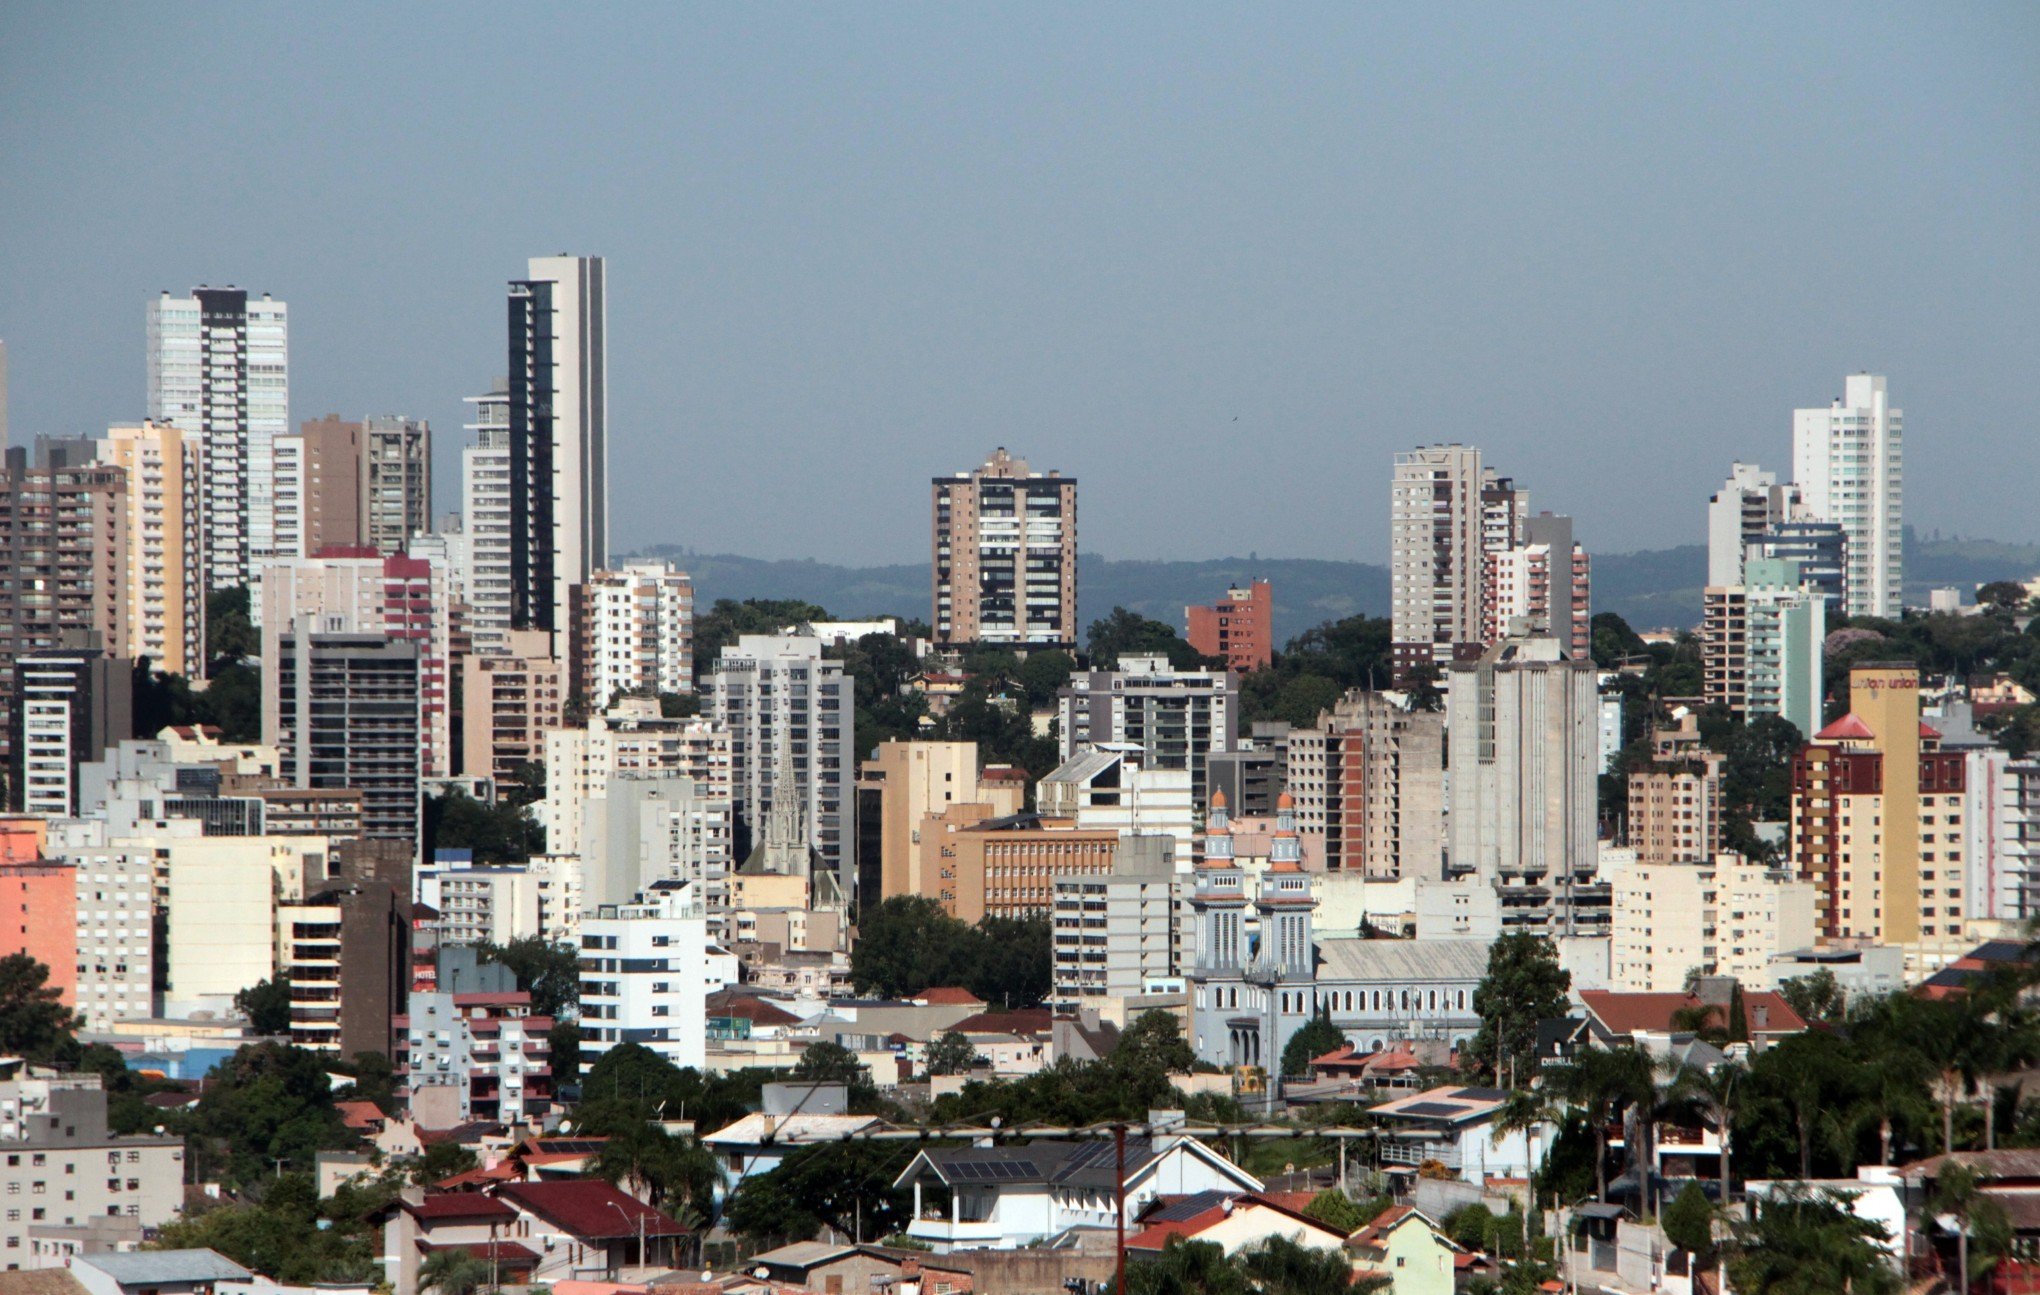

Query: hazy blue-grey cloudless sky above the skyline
left=0, top=0, right=2040, bottom=561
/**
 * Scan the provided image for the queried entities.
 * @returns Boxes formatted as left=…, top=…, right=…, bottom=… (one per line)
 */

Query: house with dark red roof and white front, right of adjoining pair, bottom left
left=493, top=1179, right=687, bottom=1295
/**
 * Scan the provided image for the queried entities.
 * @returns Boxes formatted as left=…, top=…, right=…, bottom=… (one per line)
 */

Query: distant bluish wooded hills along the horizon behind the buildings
left=645, top=534, right=2040, bottom=642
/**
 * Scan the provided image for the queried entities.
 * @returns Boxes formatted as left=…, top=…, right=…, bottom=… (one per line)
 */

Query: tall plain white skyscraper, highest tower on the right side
left=1791, top=373, right=1905, bottom=616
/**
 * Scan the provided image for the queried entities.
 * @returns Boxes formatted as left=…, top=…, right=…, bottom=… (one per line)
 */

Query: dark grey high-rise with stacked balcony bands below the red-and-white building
left=263, top=632, right=424, bottom=844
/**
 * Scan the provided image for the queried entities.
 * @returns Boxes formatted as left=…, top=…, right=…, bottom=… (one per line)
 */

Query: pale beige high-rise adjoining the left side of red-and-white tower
left=1389, top=445, right=1485, bottom=679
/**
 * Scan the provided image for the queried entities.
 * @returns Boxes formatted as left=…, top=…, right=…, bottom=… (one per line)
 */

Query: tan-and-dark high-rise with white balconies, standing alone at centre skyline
left=932, top=447, right=1077, bottom=649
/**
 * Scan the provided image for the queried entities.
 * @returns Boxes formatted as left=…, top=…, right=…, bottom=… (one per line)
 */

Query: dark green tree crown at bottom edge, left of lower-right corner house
left=1728, top=1191, right=1905, bottom=1295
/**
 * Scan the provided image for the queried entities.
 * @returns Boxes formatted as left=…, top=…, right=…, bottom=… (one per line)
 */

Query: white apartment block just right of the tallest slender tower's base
left=569, top=559, right=694, bottom=710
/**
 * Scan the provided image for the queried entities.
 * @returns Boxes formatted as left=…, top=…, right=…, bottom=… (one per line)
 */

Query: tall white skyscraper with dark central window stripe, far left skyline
left=149, top=288, right=292, bottom=591
